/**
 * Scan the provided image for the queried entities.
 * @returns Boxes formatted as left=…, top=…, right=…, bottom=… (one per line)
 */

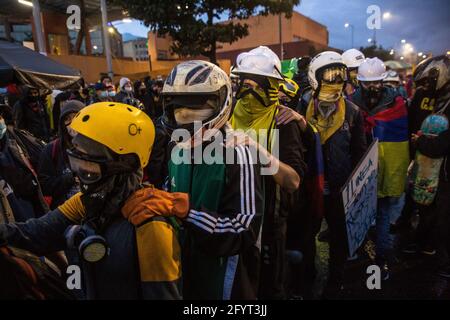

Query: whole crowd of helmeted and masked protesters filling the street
left=0, top=46, right=450, bottom=300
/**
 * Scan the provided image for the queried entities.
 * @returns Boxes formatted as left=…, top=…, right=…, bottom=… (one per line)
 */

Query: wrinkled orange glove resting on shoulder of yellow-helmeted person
left=122, top=187, right=189, bottom=226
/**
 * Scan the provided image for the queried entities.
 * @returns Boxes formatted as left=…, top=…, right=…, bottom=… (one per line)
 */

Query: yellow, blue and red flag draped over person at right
left=366, top=97, right=409, bottom=198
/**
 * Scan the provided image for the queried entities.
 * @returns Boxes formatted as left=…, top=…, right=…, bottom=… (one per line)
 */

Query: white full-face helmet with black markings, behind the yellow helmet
left=161, top=60, right=232, bottom=135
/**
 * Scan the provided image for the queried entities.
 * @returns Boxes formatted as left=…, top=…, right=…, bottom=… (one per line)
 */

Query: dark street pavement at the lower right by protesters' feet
left=314, top=222, right=450, bottom=300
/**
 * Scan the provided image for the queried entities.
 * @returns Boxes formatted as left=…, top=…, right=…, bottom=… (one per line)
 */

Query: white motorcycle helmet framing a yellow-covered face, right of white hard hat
left=308, top=51, right=346, bottom=91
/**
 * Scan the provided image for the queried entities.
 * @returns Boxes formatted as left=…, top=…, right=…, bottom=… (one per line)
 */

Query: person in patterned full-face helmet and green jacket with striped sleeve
left=162, top=60, right=263, bottom=300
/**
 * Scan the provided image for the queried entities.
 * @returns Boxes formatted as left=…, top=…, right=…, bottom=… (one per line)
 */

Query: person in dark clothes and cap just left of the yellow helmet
left=38, top=100, right=85, bottom=209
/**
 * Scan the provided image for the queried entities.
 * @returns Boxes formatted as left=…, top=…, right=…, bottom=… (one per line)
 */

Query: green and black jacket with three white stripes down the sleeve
left=169, top=146, right=264, bottom=300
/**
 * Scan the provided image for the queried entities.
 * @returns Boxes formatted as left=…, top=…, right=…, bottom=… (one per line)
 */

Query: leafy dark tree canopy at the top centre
left=113, top=0, right=300, bottom=63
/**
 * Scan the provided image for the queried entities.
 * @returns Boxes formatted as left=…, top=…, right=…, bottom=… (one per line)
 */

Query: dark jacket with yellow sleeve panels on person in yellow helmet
left=0, top=190, right=181, bottom=300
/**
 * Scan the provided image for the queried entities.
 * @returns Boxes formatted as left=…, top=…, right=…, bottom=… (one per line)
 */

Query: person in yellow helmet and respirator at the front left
left=0, top=102, right=189, bottom=299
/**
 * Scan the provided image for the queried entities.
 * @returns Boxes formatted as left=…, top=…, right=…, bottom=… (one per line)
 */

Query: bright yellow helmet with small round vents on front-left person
left=70, top=102, right=155, bottom=167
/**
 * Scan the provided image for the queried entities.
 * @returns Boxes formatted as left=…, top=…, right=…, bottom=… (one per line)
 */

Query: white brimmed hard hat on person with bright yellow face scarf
left=231, top=46, right=283, bottom=80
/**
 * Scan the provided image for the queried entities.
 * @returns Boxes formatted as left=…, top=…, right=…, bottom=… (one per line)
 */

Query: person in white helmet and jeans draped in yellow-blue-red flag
left=352, top=58, right=409, bottom=280
